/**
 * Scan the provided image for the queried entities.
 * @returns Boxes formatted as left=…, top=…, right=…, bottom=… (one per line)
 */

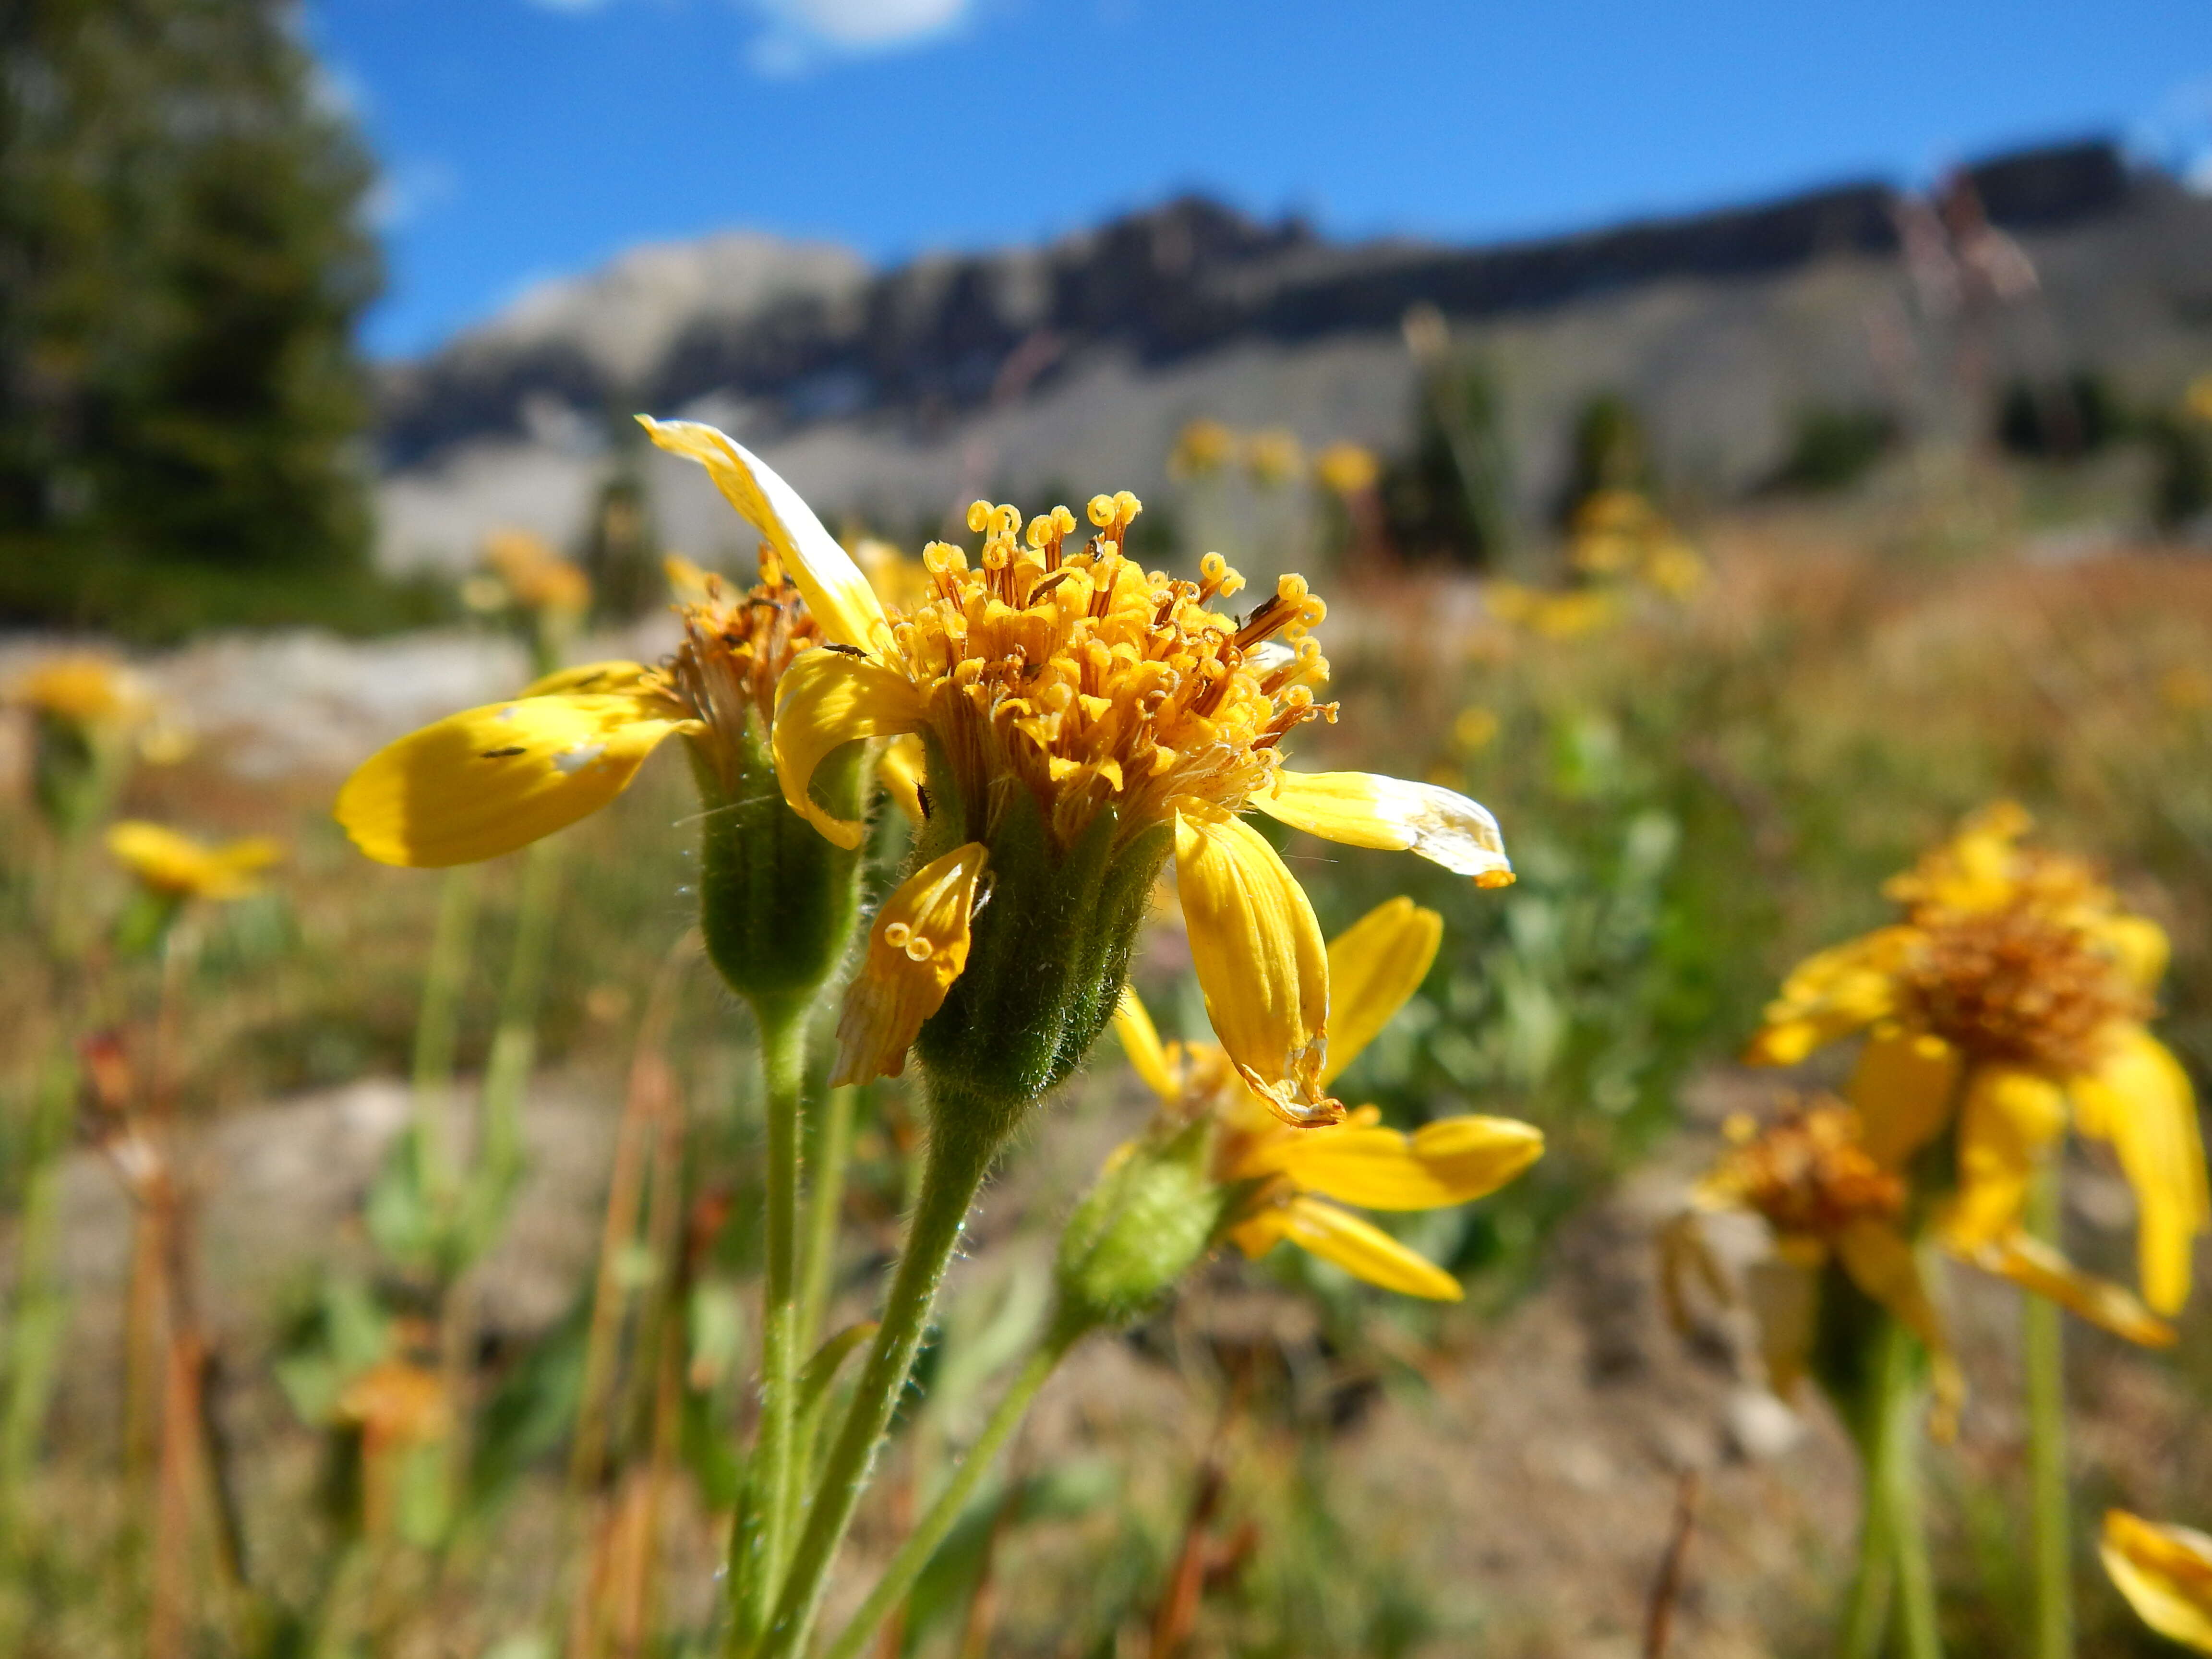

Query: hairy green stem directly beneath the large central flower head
left=757, top=1110, right=1000, bottom=1659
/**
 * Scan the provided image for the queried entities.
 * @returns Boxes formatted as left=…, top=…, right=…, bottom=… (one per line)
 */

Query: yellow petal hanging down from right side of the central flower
left=1175, top=801, right=1345, bottom=1124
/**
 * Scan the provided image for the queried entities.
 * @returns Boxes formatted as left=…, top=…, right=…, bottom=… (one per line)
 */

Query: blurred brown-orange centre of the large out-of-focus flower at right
left=1904, top=905, right=2148, bottom=1077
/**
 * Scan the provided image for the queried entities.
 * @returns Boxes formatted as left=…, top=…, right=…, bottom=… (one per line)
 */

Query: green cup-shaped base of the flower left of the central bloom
left=690, top=721, right=869, bottom=1013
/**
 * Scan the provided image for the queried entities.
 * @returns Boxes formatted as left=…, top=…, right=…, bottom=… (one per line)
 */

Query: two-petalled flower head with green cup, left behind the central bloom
left=338, top=421, right=914, bottom=998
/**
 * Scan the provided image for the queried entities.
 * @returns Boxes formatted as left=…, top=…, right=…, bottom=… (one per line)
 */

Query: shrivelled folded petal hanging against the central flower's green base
left=830, top=841, right=989, bottom=1086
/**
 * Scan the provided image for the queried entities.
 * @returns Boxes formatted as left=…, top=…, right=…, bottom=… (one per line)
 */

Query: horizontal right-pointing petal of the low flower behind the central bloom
left=1256, top=1117, right=1544, bottom=1210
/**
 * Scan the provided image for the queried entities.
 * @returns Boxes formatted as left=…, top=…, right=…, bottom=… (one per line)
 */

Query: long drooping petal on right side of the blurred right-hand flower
left=2068, top=1024, right=2212, bottom=1314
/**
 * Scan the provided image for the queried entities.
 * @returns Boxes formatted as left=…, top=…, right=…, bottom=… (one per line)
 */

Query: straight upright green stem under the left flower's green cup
left=730, top=1000, right=807, bottom=1655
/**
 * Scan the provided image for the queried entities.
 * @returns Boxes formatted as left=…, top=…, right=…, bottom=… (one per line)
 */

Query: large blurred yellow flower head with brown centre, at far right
left=1750, top=803, right=2212, bottom=1314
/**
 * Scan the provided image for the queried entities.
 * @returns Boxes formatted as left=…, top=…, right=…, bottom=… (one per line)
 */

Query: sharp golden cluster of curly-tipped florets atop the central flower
left=891, top=491, right=1336, bottom=843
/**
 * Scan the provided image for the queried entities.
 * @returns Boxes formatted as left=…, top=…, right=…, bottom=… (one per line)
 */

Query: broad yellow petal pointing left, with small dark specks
left=338, top=697, right=681, bottom=867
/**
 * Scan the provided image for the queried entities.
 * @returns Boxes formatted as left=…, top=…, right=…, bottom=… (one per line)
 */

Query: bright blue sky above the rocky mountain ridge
left=308, top=0, right=2212, bottom=354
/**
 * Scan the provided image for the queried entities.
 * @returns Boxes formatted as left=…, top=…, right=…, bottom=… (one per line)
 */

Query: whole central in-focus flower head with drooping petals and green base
left=769, top=480, right=1511, bottom=1124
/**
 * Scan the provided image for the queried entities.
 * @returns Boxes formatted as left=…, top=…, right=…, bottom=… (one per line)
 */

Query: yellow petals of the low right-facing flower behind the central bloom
left=1115, top=898, right=1544, bottom=1301
